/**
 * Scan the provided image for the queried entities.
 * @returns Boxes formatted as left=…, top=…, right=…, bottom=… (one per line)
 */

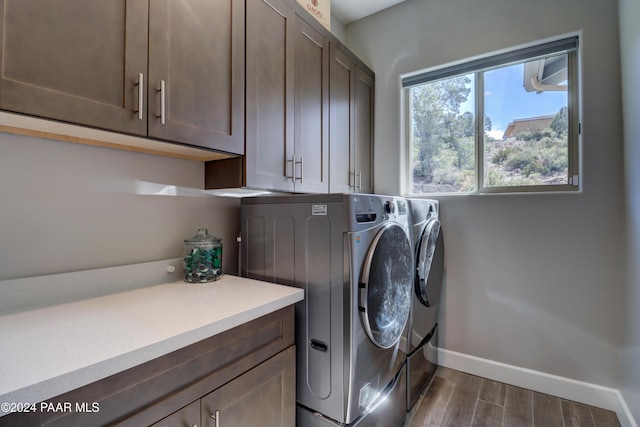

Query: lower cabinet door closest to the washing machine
left=200, top=346, right=296, bottom=427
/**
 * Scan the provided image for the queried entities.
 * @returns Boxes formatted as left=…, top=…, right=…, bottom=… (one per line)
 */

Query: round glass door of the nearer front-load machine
left=359, top=224, right=413, bottom=348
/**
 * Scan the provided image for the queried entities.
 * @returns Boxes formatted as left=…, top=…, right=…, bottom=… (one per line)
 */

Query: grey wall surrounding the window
left=346, top=0, right=625, bottom=388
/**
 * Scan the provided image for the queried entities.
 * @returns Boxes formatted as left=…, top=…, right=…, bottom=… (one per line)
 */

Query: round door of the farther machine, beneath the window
left=415, top=219, right=444, bottom=307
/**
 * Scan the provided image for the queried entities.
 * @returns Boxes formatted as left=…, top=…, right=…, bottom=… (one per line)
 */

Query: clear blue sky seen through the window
left=461, top=64, right=567, bottom=138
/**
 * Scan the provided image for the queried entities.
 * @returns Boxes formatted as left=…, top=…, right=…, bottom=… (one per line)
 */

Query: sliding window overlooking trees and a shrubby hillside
left=402, top=37, right=579, bottom=194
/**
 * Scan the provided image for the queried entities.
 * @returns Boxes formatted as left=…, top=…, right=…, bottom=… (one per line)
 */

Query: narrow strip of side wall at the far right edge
left=620, top=0, right=640, bottom=420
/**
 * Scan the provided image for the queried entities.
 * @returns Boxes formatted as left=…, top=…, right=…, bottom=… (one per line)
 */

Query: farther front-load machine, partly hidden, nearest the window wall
left=405, top=199, right=444, bottom=411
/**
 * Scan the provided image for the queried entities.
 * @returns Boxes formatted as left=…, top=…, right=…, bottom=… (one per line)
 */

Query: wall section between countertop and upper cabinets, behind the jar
left=0, top=133, right=240, bottom=282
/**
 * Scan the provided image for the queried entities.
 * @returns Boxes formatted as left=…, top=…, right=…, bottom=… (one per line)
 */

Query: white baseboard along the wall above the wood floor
left=438, top=348, right=638, bottom=427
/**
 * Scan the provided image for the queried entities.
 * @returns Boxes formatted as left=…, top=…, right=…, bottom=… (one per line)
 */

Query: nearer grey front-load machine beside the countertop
left=241, top=194, right=413, bottom=427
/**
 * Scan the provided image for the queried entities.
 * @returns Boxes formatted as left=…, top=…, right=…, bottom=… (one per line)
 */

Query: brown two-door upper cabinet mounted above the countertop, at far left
left=0, top=0, right=244, bottom=154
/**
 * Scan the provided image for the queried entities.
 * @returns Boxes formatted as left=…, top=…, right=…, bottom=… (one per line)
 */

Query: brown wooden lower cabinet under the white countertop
left=0, top=306, right=296, bottom=427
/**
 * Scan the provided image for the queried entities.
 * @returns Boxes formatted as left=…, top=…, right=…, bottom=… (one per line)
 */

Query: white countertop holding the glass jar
left=0, top=275, right=303, bottom=416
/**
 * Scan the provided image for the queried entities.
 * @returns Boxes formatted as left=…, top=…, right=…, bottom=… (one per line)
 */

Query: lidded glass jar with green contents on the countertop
left=182, top=228, right=222, bottom=283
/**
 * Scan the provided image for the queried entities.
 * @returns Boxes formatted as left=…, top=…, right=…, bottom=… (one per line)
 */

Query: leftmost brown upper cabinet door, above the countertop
left=0, top=0, right=149, bottom=135
